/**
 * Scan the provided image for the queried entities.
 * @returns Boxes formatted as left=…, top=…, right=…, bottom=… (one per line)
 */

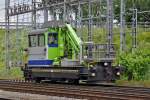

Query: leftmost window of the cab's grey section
left=29, top=35, right=38, bottom=47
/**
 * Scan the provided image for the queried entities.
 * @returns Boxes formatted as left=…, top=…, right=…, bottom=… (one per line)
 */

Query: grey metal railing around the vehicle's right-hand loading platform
left=82, top=42, right=115, bottom=62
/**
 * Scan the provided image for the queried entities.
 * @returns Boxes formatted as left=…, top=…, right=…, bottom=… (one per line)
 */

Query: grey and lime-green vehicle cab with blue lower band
left=28, top=29, right=60, bottom=67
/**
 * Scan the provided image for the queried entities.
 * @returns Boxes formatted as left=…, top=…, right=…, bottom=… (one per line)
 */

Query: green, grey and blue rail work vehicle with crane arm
left=23, top=22, right=119, bottom=83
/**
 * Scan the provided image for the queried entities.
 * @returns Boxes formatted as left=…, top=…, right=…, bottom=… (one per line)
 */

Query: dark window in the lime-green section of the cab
left=48, top=33, right=58, bottom=45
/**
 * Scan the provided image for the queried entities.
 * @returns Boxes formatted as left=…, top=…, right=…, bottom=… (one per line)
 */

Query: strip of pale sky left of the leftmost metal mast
left=0, top=0, right=5, bottom=22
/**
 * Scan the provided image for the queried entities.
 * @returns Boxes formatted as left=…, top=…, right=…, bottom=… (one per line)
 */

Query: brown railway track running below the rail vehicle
left=0, top=81, right=150, bottom=100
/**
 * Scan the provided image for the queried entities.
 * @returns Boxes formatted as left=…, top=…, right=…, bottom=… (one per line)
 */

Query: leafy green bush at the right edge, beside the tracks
left=118, top=32, right=150, bottom=81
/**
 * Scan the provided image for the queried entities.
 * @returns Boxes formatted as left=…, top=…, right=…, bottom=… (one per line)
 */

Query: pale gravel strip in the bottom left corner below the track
left=0, top=90, right=85, bottom=100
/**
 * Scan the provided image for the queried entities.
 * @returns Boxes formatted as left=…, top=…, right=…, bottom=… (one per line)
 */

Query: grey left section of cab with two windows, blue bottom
left=28, top=34, right=46, bottom=66
